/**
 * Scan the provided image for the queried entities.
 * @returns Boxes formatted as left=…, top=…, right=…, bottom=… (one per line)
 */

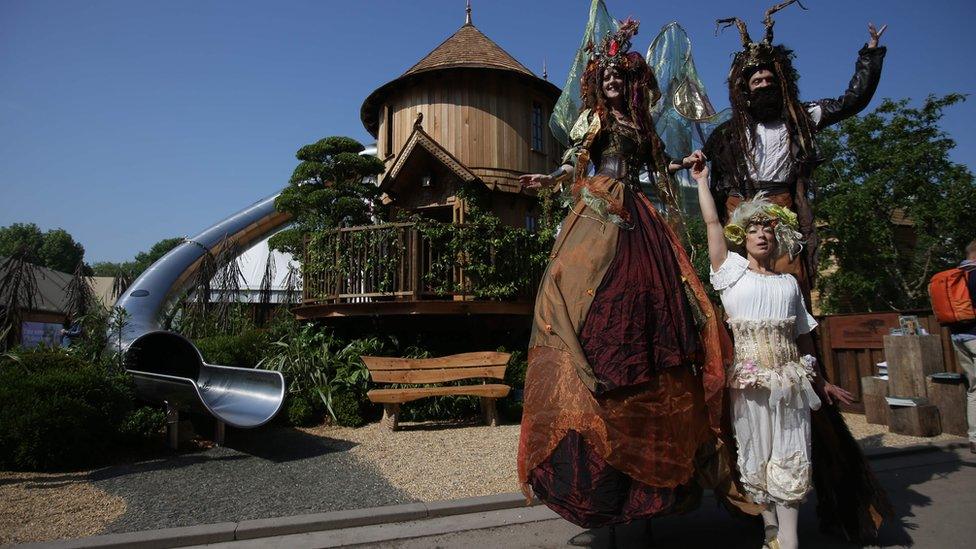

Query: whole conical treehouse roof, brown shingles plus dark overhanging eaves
left=359, top=20, right=559, bottom=137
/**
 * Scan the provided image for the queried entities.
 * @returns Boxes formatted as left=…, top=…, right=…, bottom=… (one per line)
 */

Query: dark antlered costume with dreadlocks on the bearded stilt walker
left=703, top=2, right=892, bottom=540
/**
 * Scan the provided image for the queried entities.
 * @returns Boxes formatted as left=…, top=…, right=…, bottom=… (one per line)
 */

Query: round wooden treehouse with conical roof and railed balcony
left=294, top=11, right=562, bottom=334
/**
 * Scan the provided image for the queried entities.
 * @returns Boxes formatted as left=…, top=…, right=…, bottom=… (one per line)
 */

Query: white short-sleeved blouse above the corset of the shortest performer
left=710, top=251, right=817, bottom=335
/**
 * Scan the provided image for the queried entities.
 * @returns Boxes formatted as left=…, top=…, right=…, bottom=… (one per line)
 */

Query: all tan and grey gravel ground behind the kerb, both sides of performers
left=0, top=414, right=962, bottom=543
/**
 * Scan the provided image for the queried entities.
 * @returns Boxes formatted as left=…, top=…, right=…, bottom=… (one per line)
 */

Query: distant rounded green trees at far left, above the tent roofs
left=0, top=223, right=85, bottom=273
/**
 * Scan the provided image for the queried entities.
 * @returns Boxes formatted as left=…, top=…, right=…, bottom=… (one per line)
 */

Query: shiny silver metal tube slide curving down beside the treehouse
left=109, top=194, right=291, bottom=428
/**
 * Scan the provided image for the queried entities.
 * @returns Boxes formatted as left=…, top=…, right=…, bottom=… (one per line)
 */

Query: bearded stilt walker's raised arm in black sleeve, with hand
left=816, top=23, right=888, bottom=128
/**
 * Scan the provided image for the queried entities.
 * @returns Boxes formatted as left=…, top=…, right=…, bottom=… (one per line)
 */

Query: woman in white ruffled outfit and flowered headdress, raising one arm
left=692, top=151, right=853, bottom=549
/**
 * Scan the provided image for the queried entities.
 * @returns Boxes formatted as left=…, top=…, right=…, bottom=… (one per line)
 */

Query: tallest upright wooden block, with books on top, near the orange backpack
left=884, top=335, right=945, bottom=398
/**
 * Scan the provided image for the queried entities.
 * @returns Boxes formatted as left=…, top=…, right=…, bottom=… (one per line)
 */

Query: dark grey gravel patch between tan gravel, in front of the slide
left=90, top=427, right=414, bottom=533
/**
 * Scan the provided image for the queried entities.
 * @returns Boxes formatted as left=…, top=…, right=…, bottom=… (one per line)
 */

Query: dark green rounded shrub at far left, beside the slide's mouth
left=0, top=349, right=138, bottom=470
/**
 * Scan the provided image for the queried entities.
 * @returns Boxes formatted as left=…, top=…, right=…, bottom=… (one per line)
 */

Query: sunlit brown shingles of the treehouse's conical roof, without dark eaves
left=401, top=23, right=535, bottom=78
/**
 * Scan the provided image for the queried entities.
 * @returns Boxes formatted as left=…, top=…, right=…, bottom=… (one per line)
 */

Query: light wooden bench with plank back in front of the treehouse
left=362, top=352, right=512, bottom=431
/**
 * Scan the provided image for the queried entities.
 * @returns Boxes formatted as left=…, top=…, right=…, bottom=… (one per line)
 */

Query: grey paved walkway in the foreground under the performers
left=193, top=449, right=976, bottom=549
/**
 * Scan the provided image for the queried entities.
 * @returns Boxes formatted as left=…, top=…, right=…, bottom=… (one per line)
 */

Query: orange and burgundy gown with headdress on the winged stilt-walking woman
left=518, top=21, right=752, bottom=528
